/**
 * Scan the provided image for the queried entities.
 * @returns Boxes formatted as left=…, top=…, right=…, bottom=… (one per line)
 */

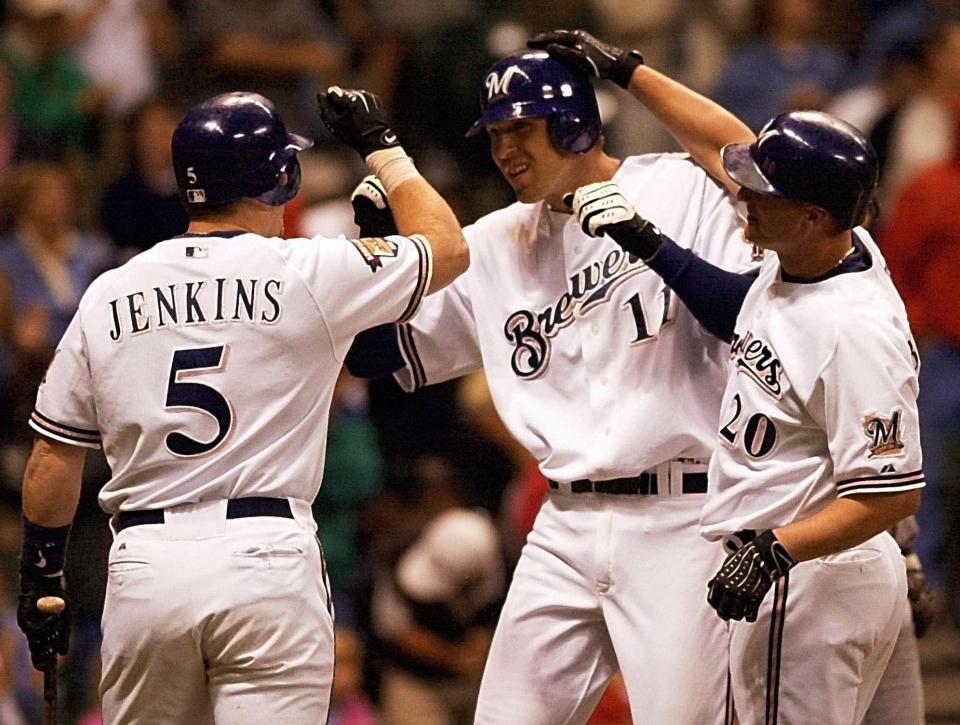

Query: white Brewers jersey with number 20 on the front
left=701, top=229, right=923, bottom=539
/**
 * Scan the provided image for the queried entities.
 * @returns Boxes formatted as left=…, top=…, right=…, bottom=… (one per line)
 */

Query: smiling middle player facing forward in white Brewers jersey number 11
left=348, top=31, right=753, bottom=725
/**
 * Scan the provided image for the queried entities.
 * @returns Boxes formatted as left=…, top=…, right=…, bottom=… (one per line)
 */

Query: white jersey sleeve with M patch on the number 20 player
left=820, top=317, right=924, bottom=497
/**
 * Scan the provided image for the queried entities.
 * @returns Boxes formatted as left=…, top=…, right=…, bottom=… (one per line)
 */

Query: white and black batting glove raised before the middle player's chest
left=563, top=181, right=663, bottom=261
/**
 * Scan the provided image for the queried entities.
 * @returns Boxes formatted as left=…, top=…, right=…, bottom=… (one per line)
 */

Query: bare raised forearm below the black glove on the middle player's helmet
left=628, top=65, right=756, bottom=193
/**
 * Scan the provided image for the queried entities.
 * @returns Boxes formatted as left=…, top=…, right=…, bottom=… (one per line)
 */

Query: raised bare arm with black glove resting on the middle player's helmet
left=527, top=30, right=755, bottom=193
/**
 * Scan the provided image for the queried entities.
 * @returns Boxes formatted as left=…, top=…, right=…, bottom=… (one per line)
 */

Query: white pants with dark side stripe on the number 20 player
left=730, top=533, right=907, bottom=725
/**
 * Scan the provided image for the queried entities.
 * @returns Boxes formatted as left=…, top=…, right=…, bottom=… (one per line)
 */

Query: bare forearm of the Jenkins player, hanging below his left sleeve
left=23, top=438, right=87, bottom=528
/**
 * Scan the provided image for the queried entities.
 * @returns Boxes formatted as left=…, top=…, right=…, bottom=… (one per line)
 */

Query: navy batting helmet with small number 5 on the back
left=172, top=92, right=313, bottom=207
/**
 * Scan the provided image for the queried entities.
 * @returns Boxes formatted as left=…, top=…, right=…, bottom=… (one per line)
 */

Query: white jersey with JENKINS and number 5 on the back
left=30, top=233, right=432, bottom=513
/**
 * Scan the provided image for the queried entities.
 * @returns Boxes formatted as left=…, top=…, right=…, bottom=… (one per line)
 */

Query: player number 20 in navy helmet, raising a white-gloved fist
left=572, top=111, right=923, bottom=725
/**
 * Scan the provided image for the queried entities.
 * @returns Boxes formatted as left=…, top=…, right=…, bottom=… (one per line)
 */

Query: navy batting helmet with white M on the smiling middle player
left=467, top=50, right=602, bottom=154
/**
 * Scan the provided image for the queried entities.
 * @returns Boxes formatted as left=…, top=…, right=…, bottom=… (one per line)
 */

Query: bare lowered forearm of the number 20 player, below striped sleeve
left=774, top=489, right=920, bottom=561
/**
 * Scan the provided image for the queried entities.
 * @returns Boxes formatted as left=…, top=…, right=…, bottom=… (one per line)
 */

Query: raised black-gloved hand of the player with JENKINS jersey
left=317, top=86, right=400, bottom=159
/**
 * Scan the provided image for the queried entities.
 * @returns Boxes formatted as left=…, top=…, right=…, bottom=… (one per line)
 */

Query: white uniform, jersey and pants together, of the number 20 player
left=701, top=229, right=923, bottom=725
